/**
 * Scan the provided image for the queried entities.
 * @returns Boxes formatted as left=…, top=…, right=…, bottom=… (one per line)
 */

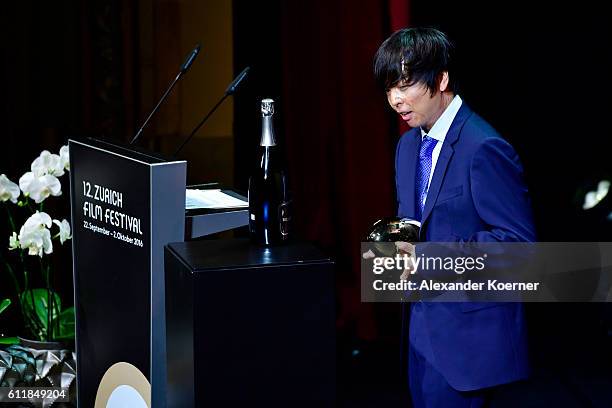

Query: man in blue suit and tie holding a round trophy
left=374, top=28, right=535, bottom=408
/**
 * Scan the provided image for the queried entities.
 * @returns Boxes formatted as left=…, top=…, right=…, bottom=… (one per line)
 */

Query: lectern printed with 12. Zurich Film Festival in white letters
left=69, top=139, right=248, bottom=408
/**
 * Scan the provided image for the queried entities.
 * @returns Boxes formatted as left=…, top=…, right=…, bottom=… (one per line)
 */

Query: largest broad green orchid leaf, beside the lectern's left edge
left=19, top=288, right=62, bottom=341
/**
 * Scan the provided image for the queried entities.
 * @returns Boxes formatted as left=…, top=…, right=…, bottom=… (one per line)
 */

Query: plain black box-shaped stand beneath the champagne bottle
left=165, top=239, right=336, bottom=407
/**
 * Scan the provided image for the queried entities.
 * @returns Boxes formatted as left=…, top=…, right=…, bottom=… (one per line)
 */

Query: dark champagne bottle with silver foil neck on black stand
left=249, top=99, right=291, bottom=245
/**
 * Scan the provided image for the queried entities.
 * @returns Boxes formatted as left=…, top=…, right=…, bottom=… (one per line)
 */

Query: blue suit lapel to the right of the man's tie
left=421, top=102, right=472, bottom=231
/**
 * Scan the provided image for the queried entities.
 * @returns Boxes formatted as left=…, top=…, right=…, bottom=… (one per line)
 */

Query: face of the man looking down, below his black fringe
left=387, top=73, right=448, bottom=130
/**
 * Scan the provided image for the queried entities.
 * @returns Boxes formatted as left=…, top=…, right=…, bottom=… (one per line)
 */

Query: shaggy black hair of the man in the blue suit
left=374, top=28, right=455, bottom=95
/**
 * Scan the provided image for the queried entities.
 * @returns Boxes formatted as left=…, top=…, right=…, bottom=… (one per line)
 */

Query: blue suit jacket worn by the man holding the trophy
left=395, top=102, right=535, bottom=391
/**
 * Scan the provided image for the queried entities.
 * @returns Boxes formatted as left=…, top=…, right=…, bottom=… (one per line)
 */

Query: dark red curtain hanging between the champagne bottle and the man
left=281, top=0, right=396, bottom=339
